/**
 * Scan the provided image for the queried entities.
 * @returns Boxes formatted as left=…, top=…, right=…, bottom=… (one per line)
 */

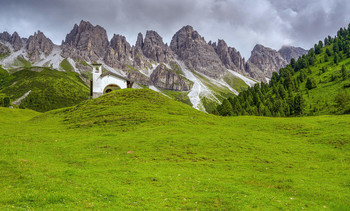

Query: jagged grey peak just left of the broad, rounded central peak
left=140, top=31, right=173, bottom=63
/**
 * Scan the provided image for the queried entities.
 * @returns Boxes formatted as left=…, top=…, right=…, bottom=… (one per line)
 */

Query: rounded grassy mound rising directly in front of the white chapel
left=54, top=89, right=205, bottom=127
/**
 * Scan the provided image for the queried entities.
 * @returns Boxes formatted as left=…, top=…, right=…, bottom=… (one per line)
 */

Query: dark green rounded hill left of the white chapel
left=0, top=67, right=89, bottom=112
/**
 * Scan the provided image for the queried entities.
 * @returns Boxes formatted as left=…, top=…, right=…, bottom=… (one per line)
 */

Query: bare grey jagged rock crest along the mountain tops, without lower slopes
left=0, top=20, right=307, bottom=83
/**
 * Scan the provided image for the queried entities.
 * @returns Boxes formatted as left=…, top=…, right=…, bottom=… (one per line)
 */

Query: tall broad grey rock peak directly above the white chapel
left=62, top=21, right=109, bottom=61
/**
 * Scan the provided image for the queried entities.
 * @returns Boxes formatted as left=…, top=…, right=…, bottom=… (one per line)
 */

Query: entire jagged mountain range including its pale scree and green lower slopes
left=0, top=20, right=307, bottom=110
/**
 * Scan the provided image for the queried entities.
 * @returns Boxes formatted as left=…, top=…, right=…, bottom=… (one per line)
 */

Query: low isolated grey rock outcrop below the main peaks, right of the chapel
left=150, top=64, right=193, bottom=91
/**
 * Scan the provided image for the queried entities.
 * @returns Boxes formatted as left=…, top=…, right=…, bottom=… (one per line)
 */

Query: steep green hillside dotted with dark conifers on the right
left=217, top=27, right=350, bottom=116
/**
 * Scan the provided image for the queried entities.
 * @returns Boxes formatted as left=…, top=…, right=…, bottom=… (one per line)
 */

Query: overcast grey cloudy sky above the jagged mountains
left=0, top=0, right=350, bottom=58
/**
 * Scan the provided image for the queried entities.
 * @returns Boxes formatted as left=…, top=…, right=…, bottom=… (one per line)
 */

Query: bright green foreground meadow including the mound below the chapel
left=0, top=89, right=350, bottom=210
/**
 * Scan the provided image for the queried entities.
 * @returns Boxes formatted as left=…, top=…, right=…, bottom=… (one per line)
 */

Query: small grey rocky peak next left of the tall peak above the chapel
left=26, top=31, right=54, bottom=62
